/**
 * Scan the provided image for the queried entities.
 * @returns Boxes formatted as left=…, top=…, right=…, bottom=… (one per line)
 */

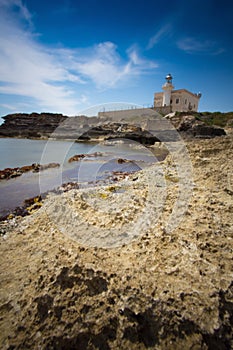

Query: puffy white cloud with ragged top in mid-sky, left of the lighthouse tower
left=57, top=42, right=157, bottom=89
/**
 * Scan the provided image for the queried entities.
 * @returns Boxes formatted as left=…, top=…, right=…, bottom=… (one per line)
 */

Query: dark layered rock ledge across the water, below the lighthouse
left=0, top=110, right=228, bottom=141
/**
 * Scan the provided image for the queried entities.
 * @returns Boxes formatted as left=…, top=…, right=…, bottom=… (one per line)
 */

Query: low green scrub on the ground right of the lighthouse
left=176, top=111, right=233, bottom=128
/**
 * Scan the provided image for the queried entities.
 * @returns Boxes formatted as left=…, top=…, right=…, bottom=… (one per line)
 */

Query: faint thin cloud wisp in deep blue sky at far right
left=177, top=37, right=224, bottom=55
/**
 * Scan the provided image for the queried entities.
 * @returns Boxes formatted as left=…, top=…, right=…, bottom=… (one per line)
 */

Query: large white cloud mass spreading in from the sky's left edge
left=0, top=0, right=157, bottom=114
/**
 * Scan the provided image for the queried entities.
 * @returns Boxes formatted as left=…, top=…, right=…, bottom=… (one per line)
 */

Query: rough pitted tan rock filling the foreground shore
left=0, top=133, right=233, bottom=350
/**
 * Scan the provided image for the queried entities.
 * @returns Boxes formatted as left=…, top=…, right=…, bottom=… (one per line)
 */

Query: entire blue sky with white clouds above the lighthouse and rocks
left=0, top=0, right=233, bottom=120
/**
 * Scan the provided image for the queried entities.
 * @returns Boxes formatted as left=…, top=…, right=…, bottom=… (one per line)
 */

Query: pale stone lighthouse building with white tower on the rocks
left=154, top=74, right=201, bottom=112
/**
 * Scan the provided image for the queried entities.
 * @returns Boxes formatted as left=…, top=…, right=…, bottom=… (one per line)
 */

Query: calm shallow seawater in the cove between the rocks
left=0, top=138, right=157, bottom=216
